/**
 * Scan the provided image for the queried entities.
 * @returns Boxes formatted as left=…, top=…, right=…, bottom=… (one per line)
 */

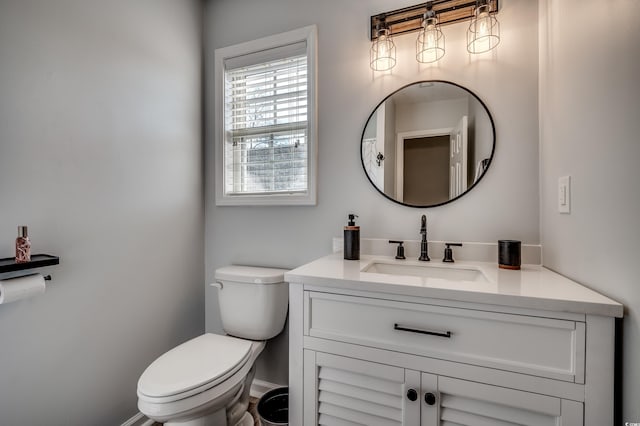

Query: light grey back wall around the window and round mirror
left=205, top=0, right=539, bottom=383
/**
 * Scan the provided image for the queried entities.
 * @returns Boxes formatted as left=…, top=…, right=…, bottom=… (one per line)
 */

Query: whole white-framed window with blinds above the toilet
left=215, top=26, right=317, bottom=205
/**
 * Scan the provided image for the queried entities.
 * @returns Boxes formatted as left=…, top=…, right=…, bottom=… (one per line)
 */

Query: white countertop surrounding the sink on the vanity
left=285, top=253, right=623, bottom=317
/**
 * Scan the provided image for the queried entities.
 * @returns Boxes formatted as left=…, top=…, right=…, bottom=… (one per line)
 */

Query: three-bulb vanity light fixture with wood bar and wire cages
left=370, top=0, right=500, bottom=71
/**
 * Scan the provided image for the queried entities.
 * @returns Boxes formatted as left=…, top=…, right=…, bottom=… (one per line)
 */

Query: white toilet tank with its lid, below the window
left=215, top=265, right=289, bottom=340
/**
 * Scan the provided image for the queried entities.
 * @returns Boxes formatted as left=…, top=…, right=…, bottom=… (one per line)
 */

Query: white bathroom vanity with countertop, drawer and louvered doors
left=285, top=253, right=623, bottom=426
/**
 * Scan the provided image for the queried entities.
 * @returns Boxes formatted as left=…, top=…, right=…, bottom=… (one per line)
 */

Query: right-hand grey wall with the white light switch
left=540, top=0, right=640, bottom=422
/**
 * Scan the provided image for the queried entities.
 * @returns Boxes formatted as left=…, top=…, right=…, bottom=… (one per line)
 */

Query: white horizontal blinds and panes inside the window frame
left=224, top=43, right=308, bottom=195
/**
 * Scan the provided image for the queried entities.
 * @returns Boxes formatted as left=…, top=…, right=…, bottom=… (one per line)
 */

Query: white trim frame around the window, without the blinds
left=214, top=25, right=318, bottom=206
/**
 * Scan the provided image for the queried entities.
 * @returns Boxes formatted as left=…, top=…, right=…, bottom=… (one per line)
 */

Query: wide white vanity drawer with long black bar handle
left=304, top=291, right=585, bottom=383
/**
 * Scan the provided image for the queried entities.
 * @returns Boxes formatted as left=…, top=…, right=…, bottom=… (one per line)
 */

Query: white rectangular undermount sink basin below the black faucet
left=362, top=261, right=489, bottom=283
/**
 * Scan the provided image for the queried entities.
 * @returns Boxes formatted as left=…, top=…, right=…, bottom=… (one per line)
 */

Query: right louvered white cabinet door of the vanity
left=421, top=373, right=583, bottom=426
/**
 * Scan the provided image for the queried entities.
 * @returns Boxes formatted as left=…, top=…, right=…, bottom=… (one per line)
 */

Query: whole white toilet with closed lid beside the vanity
left=137, top=266, right=289, bottom=426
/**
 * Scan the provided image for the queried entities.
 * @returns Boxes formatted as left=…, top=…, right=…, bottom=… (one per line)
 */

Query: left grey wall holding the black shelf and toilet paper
left=0, top=0, right=204, bottom=426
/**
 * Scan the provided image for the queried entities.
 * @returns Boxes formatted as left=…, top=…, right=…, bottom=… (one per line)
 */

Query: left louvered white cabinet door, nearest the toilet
left=304, top=350, right=420, bottom=426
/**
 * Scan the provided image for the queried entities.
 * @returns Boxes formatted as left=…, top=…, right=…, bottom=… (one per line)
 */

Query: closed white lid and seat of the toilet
left=138, top=333, right=251, bottom=397
